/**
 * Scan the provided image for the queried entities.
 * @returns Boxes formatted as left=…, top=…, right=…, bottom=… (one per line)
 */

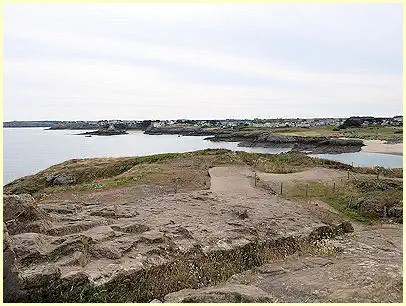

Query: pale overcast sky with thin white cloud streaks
left=3, top=3, right=402, bottom=121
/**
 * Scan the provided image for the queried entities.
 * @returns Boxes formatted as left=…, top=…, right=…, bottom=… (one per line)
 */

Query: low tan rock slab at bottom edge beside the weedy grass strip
left=164, top=284, right=275, bottom=303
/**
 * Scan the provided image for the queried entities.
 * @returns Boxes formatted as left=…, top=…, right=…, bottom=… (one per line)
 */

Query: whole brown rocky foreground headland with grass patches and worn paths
left=3, top=150, right=403, bottom=302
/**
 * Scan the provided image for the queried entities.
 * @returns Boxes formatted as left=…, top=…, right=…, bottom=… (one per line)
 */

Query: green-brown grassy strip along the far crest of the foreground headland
left=3, top=149, right=402, bottom=196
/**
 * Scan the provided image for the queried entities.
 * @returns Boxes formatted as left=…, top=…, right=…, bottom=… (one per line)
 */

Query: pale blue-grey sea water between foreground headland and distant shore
left=3, top=128, right=403, bottom=185
